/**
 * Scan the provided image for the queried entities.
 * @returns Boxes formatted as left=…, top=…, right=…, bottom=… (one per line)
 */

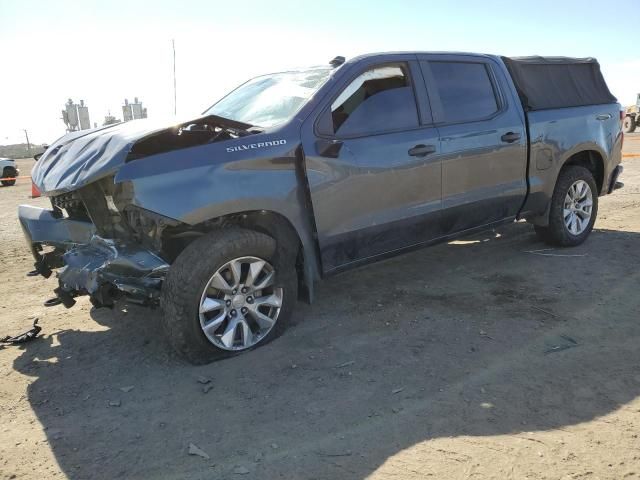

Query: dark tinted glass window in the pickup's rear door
left=427, top=61, right=500, bottom=123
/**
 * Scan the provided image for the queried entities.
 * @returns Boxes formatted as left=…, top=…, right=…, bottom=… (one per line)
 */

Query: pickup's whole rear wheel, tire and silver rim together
left=535, top=165, right=598, bottom=247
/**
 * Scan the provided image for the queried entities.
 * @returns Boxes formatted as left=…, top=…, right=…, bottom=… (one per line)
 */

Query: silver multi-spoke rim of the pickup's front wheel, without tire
left=198, top=257, right=283, bottom=351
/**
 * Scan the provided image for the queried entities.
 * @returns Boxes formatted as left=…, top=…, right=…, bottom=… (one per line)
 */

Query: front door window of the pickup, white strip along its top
left=331, top=65, right=419, bottom=136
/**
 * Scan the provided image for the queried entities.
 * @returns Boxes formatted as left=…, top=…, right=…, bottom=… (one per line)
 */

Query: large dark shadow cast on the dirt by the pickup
left=14, top=224, right=640, bottom=479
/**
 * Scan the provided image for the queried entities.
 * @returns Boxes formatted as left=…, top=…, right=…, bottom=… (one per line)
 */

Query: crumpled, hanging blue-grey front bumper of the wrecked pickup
left=18, top=205, right=169, bottom=307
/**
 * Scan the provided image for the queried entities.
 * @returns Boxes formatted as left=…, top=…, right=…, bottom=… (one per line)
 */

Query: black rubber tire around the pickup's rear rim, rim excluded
left=534, top=165, right=598, bottom=247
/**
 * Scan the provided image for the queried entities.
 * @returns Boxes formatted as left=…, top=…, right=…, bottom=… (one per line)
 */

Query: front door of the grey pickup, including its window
left=302, top=55, right=442, bottom=272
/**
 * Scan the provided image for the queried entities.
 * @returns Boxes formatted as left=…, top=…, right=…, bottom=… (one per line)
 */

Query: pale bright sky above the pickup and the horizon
left=0, top=0, right=640, bottom=144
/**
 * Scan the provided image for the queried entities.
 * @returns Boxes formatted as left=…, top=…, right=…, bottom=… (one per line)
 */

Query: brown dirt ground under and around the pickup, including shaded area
left=0, top=135, right=640, bottom=480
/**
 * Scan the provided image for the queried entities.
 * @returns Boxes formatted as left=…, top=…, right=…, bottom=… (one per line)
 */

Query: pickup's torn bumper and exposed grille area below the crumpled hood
left=18, top=179, right=175, bottom=308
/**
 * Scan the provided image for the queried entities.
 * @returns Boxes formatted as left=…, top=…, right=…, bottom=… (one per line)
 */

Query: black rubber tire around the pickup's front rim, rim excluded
left=160, top=227, right=298, bottom=364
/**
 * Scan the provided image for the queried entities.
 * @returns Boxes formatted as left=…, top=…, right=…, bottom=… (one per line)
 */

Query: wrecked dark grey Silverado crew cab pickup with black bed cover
left=19, top=53, right=623, bottom=363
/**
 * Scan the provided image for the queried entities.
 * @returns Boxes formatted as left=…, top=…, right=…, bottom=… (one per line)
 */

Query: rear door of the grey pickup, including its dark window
left=419, top=54, right=527, bottom=234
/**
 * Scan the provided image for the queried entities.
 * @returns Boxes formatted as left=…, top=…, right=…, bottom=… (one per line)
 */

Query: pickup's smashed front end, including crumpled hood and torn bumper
left=18, top=115, right=259, bottom=307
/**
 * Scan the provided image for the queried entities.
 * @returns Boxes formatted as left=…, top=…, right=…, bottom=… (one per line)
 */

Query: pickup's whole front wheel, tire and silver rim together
left=160, top=228, right=297, bottom=364
